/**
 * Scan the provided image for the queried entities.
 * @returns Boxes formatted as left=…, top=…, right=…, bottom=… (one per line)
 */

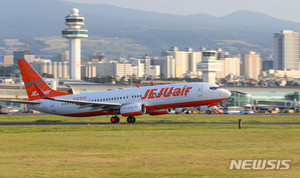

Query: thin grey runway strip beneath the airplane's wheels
left=0, top=122, right=300, bottom=126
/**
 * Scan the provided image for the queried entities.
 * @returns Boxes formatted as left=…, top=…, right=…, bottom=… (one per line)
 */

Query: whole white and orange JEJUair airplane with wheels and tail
left=2, top=59, right=231, bottom=124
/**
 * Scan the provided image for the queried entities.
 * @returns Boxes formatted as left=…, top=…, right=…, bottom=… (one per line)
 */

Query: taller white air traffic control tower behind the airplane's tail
left=62, top=8, right=88, bottom=80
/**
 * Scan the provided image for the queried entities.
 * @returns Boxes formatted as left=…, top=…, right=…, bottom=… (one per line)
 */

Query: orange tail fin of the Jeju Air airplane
left=17, top=59, right=70, bottom=101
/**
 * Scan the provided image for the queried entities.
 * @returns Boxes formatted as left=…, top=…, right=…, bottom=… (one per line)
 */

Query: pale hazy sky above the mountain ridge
left=66, top=0, right=300, bottom=22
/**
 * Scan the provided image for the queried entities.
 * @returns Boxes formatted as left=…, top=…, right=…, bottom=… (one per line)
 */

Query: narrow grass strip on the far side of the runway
left=0, top=114, right=300, bottom=123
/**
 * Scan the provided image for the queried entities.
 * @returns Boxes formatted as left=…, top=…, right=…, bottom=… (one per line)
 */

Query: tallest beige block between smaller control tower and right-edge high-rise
left=241, top=52, right=262, bottom=79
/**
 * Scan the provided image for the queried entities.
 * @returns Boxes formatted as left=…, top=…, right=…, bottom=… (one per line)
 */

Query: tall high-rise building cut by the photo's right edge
left=273, top=30, right=300, bottom=70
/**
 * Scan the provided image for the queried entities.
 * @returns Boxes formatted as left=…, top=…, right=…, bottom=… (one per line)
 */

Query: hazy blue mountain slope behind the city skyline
left=0, top=0, right=300, bottom=56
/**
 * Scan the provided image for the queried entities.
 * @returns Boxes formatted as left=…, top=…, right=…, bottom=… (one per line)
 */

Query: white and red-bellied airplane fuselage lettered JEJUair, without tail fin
left=29, top=83, right=230, bottom=116
